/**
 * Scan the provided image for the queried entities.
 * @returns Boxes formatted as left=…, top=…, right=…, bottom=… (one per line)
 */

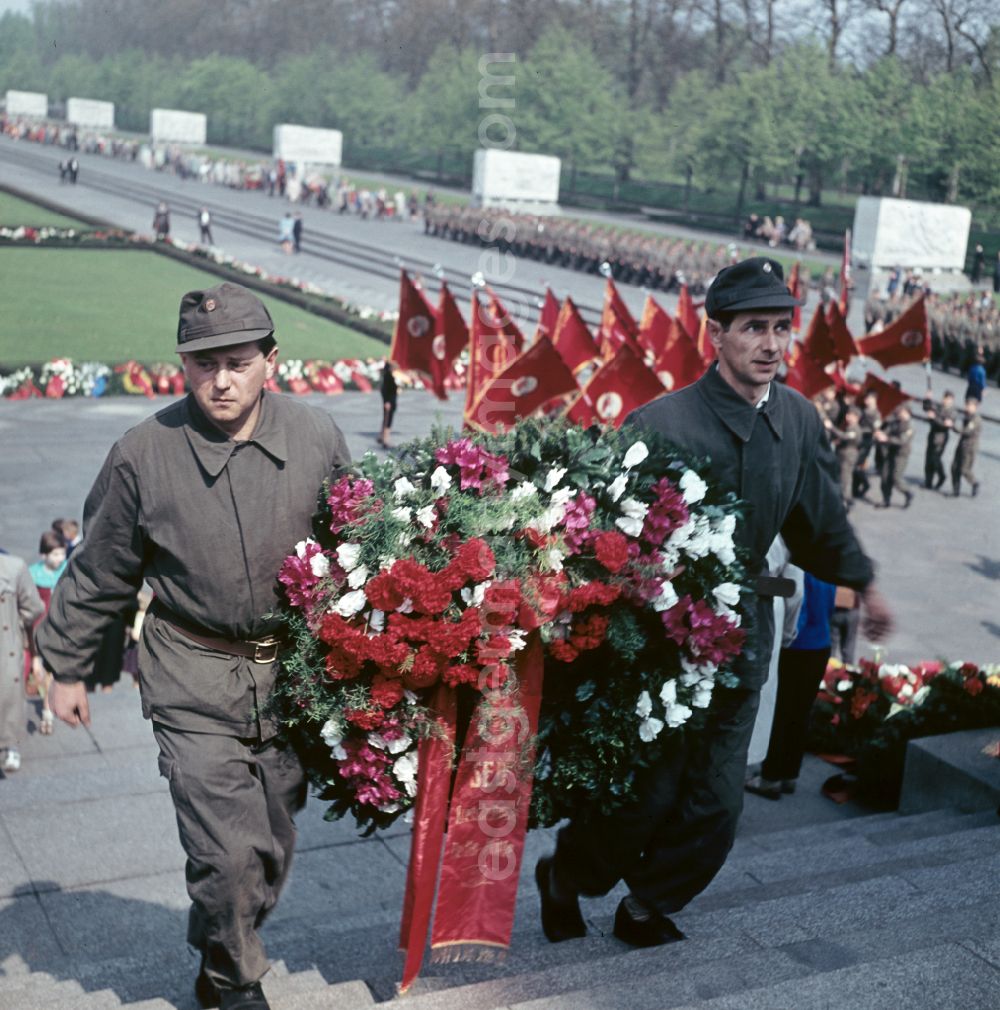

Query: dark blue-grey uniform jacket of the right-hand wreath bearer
left=626, top=366, right=874, bottom=688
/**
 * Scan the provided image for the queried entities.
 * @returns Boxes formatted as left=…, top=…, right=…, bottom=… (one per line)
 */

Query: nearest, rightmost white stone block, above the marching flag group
left=852, top=196, right=972, bottom=271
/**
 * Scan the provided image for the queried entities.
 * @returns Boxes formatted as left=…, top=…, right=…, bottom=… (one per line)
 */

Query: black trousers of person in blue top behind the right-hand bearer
left=761, top=647, right=830, bottom=782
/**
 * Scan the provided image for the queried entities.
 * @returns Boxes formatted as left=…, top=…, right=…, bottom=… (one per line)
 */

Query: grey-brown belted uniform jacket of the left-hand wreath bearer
left=35, top=393, right=349, bottom=736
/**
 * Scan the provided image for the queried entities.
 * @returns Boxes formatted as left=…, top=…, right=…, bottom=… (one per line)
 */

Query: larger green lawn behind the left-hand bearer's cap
left=0, top=248, right=388, bottom=367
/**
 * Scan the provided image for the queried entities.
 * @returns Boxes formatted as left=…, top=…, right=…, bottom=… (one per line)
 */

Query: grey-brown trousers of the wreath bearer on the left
left=154, top=723, right=306, bottom=989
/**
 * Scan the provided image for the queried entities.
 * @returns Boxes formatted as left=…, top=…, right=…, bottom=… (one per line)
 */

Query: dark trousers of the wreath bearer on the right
left=555, top=688, right=761, bottom=915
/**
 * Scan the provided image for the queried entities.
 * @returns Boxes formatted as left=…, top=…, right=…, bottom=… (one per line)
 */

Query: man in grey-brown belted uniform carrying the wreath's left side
left=36, top=284, right=349, bottom=1010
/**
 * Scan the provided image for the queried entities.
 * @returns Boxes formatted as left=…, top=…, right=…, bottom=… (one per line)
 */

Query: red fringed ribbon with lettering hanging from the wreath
left=400, top=631, right=543, bottom=992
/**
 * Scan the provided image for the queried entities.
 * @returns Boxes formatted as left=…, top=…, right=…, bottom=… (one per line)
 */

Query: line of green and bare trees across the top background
left=0, top=0, right=1000, bottom=221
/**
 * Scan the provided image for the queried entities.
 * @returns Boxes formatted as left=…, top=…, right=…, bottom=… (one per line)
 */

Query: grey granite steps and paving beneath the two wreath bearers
left=0, top=688, right=1000, bottom=1010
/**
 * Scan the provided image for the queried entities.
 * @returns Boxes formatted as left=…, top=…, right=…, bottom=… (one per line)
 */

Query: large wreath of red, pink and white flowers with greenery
left=276, top=421, right=745, bottom=828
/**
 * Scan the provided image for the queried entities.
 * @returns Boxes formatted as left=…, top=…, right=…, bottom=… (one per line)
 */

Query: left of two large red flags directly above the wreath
left=466, top=336, right=579, bottom=431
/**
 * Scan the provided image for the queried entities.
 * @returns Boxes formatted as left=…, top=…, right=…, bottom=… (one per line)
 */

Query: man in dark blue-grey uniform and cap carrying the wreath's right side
left=535, top=258, right=891, bottom=946
